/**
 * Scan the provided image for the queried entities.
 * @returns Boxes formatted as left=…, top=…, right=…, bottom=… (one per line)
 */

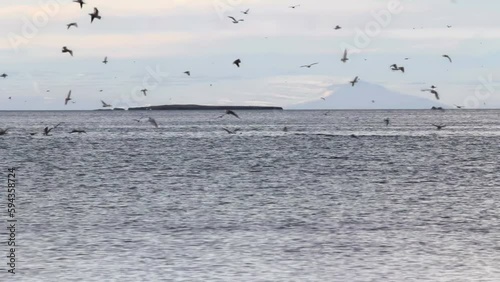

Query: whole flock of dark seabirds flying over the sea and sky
left=0, top=0, right=470, bottom=136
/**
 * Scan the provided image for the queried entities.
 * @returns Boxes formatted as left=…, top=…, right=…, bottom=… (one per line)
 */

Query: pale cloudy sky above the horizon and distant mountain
left=0, top=0, right=500, bottom=110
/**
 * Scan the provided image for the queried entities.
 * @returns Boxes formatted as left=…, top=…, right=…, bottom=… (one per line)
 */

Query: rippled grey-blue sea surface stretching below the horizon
left=0, top=110, right=500, bottom=282
